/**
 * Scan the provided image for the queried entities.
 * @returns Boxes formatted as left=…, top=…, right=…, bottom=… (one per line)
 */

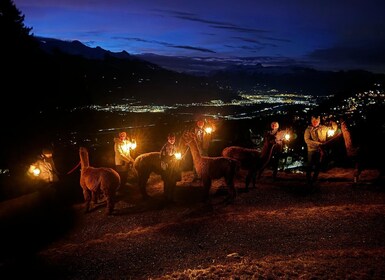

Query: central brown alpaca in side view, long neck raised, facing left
left=182, top=132, right=240, bottom=202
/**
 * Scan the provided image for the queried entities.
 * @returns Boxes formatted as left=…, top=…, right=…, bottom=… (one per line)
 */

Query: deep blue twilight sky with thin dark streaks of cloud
left=14, top=0, right=385, bottom=73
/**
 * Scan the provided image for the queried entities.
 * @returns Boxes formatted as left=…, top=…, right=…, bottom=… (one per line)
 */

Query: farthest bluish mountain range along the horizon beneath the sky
left=37, top=37, right=385, bottom=98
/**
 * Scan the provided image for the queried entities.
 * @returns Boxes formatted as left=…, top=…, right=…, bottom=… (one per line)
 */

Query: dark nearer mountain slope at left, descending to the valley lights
left=36, top=37, right=235, bottom=105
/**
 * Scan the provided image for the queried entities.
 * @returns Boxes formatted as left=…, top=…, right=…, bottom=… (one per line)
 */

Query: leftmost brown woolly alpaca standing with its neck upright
left=79, top=147, right=120, bottom=215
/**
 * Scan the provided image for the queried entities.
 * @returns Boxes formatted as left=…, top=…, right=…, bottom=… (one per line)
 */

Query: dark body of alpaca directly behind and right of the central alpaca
left=222, top=146, right=262, bottom=191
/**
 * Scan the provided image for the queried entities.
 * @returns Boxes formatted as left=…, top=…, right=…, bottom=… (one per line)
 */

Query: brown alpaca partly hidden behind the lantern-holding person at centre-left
left=134, top=152, right=162, bottom=199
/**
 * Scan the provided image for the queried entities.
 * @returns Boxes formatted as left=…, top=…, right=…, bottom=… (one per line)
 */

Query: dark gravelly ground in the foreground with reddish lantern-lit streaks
left=0, top=168, right=385, bottom=279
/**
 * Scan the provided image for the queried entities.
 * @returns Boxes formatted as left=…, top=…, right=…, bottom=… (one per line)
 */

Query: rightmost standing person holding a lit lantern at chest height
left=304, top=116, right=328, bottom=185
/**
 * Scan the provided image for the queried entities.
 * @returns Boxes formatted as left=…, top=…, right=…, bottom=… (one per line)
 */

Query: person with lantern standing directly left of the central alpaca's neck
left=160, top=133, right=181, bottom=202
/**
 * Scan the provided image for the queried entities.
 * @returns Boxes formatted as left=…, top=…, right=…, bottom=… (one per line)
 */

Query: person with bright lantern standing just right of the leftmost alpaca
left=114, top=131, right=134, bottom=187
